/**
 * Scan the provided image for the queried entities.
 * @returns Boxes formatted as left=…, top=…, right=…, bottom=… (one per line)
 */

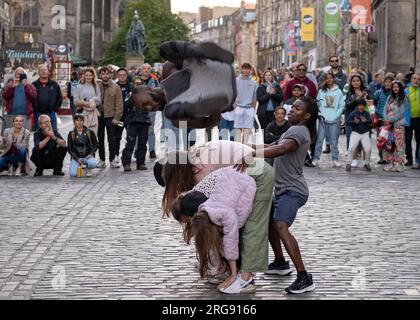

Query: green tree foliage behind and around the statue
left=101, top=0, right=189, bottom=66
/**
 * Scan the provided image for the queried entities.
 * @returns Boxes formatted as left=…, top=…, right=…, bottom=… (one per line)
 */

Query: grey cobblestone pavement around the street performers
left=0, top=115, right=420, bottom=300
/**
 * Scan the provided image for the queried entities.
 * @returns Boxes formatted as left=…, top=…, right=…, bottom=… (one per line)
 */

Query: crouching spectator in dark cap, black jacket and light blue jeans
left=67, top=113, right=98, bottom=177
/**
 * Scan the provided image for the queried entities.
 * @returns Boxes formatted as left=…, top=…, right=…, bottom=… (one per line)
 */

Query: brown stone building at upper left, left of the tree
left=9, top=0, right=125, bottom=64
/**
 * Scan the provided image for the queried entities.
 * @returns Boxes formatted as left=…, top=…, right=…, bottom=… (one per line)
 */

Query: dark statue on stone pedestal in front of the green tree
left=126, top=10, right=146, bottom=69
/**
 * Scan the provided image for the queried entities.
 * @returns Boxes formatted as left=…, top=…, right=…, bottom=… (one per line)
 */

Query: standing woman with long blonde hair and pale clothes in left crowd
left=74, top=67, right=102, bottom=135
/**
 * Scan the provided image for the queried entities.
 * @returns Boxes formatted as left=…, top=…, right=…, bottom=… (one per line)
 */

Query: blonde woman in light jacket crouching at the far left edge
left=0, top=115, right=30, bottom=177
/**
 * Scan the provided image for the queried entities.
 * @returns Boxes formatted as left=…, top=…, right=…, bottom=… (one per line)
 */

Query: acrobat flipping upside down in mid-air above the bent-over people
left=133, top=41, right=236, bottom=129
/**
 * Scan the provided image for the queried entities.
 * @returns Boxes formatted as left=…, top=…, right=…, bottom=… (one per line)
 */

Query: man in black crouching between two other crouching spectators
left=31, top=114, right=67, bottom=177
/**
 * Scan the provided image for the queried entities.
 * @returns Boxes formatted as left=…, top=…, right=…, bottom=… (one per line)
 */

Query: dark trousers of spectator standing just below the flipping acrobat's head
left=122, top=123, right=149, bottom=165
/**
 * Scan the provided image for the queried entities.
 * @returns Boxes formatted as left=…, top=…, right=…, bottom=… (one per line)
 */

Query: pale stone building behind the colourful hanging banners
left=257, top=0, right=368, bottom=70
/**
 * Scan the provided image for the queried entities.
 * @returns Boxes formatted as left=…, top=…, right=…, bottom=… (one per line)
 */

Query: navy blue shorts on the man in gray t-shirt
left=270, top=190, right=309, bottom=227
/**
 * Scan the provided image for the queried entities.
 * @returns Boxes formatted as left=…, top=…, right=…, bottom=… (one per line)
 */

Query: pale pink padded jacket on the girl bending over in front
left=199, top=167, right=257, bottom=260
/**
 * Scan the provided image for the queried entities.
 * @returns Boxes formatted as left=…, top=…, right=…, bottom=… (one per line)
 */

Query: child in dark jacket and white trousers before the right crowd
left=346, top=99, right=372, bottom=172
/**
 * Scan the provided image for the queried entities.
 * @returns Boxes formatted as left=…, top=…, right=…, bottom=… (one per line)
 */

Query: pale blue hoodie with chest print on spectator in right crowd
left=317, top=85, right=346, bottom=124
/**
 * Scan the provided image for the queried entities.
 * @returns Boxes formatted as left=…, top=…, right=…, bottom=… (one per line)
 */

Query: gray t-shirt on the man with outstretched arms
left=274, top=126, right=311, bottom=196
